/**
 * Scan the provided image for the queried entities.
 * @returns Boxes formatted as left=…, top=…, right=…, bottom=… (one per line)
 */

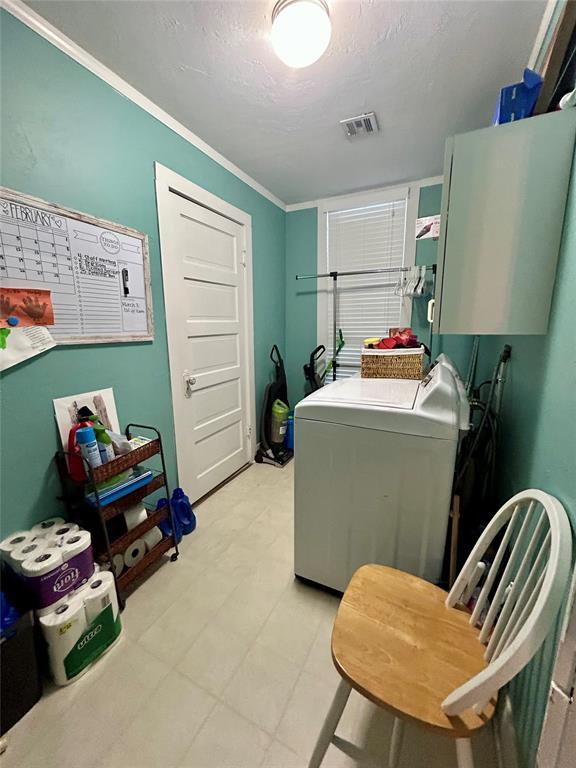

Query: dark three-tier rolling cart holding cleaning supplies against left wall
left=55, top=424, right=179, bottom=607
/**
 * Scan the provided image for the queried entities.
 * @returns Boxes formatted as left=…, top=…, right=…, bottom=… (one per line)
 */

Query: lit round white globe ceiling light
left=271, top=0, right=332, bottom=69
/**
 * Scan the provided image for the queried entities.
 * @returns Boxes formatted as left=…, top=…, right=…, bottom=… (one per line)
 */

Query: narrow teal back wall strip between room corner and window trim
left=286, top=208, right=318, bottom=406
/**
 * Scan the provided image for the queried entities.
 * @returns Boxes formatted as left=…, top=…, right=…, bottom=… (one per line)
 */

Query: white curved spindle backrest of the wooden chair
left=442, top=490, right=572, bottom=715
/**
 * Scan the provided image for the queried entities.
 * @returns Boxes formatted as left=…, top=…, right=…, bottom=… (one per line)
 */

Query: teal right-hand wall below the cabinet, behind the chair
left=472, top=144, right=576, bottom=766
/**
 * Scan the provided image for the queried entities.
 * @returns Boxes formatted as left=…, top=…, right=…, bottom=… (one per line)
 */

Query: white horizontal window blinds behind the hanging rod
left=327, top=199, right=406, bottom=378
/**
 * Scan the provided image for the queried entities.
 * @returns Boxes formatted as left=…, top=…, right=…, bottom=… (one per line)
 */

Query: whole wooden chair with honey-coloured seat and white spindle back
left=309, top=490, right=572, bottom=768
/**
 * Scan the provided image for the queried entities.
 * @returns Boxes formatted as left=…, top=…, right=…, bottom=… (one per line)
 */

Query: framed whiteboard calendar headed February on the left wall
left=0, top=187, right=154, bottom=344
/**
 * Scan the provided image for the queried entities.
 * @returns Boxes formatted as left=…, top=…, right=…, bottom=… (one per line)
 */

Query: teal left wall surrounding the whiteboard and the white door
left=0, top=11, right=286, bottom=531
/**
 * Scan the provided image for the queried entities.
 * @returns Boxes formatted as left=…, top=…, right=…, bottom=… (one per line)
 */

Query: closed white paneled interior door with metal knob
left=159, top=184, right=252, bottom=500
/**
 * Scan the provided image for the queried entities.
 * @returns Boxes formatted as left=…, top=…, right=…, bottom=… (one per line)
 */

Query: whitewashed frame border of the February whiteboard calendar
left=0, top=186, right=154, bottom=345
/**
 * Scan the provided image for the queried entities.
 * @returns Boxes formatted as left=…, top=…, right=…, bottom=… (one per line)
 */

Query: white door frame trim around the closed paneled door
left=154, top=162, right=256, bottom=486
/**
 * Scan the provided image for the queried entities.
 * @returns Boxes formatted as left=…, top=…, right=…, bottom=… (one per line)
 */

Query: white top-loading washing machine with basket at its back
left=294, top=361, right=469, bottom=592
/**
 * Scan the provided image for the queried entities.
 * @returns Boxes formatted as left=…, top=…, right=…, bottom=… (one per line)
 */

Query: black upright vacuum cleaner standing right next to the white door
left=254, top=344, right=294, bottom=467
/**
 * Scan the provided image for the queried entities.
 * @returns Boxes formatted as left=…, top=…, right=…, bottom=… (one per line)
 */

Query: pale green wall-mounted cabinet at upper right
left=436, top=110, right=576, bottom=334
